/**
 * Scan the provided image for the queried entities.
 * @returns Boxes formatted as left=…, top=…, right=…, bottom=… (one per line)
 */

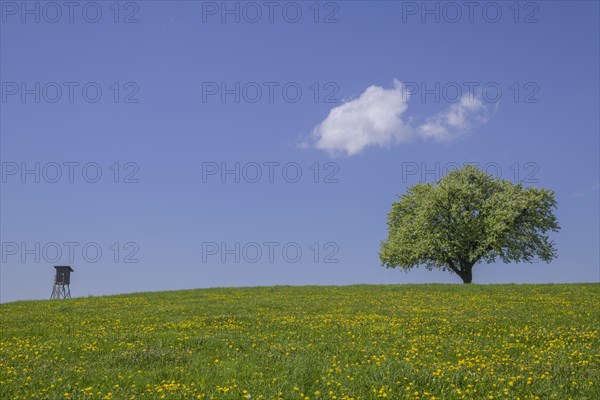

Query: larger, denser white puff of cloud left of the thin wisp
left=312, top=80, right=412, bottom=155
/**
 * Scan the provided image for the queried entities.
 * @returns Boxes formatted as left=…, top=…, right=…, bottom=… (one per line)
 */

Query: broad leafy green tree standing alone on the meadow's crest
left=379, top=165, right=560, bottom=283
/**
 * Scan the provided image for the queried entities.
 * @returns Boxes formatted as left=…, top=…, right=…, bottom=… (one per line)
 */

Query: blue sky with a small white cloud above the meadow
left=0, top=1, right=600, bottom=302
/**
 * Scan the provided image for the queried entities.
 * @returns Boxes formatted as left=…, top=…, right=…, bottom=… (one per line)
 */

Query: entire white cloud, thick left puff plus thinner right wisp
left=304, top=80, right=490, bottom=156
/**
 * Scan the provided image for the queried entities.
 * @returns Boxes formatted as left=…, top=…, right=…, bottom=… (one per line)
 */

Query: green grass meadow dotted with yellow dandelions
left=0, top=284, right=600, bottom=400
